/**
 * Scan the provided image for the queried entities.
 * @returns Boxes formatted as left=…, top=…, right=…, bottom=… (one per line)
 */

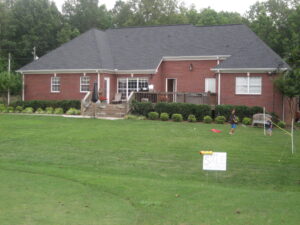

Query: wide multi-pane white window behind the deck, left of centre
left=118, top=77, right=148, bottom=99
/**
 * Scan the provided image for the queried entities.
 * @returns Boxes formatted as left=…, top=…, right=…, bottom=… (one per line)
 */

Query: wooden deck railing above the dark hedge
left=135, top=92, right=216, bottom=105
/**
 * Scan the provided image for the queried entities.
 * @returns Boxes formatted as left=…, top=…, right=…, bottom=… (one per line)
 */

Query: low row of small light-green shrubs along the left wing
left=0, top=104, right=80, bottom=115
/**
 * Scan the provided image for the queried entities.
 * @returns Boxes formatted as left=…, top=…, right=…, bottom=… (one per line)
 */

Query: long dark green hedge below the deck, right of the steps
left=131, top=101, right=263, bottom=121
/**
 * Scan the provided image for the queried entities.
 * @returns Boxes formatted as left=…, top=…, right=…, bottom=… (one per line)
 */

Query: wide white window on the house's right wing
left=235, top=77, right=261, bottom=95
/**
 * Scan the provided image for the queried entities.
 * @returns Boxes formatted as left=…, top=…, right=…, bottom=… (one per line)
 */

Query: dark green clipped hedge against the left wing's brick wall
left=11, top=100, right=81, bottom=112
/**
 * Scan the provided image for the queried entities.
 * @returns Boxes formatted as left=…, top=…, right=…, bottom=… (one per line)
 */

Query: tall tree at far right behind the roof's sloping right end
left=247, top=0, right=300, bottom=67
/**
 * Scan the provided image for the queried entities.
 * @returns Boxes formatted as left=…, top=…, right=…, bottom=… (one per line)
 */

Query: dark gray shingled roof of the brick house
left=20, top=25, right=288, bottom=71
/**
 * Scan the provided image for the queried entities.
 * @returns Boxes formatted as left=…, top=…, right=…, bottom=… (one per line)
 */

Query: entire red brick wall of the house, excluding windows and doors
left=25, top=60, right=287, bottom=117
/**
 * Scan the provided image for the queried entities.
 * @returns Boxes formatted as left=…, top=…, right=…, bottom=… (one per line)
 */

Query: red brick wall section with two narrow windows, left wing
left=25, top=74, right=97, bottom=100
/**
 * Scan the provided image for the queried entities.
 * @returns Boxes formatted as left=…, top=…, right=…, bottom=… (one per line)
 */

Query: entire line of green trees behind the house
left=0, top=0, right=300, bottom=71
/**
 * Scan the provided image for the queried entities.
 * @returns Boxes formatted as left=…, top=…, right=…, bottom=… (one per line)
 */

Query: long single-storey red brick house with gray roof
left=18, top=25, right=289, bottom=117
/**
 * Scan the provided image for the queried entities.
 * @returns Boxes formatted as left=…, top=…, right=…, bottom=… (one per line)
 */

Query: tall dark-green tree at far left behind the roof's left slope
left=6, top=0, right=62, bottom=69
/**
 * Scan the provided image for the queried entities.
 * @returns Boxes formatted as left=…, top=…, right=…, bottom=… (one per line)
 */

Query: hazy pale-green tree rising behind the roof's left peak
left=63, top=0, right=111, bottom=33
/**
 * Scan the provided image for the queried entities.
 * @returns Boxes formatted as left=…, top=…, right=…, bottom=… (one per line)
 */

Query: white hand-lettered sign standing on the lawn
left=203, top=152, right=227, bottom=171
